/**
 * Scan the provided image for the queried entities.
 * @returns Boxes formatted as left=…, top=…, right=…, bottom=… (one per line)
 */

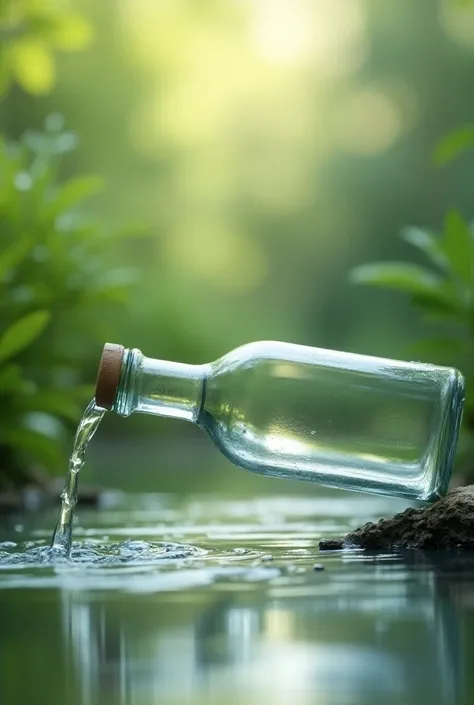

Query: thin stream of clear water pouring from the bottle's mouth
left=51, top=399, right=105, bottom=558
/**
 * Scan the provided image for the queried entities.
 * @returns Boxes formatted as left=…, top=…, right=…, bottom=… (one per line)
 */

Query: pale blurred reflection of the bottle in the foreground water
left=59, top=572, right=465, bottom=705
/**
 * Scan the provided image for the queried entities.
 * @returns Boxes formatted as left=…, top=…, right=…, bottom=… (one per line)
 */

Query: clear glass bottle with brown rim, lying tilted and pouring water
left=96, top=341, right=464, bottom=501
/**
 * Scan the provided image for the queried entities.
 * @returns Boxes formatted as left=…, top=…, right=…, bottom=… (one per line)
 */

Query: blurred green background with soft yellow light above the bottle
left=0, top=0, right=474, bottom=492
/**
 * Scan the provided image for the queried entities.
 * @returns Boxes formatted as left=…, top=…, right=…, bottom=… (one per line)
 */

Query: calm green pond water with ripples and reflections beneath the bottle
left=0, top=490, right=474, bottom=705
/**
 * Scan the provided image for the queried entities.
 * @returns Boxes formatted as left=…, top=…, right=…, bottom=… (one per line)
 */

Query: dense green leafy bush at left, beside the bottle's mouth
left=0, top=116, right=134, bottom=487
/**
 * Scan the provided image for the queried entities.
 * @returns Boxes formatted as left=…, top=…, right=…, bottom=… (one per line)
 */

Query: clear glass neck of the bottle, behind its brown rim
left=113, top=349, right=208, bottom=423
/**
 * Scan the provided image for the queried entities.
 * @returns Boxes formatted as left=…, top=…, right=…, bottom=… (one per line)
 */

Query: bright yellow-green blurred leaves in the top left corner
left=0, top=0, right=92, bottom=95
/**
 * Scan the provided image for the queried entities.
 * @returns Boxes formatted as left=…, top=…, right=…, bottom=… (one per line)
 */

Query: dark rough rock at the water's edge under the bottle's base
left=319, top=485, right=474, bottom=551
